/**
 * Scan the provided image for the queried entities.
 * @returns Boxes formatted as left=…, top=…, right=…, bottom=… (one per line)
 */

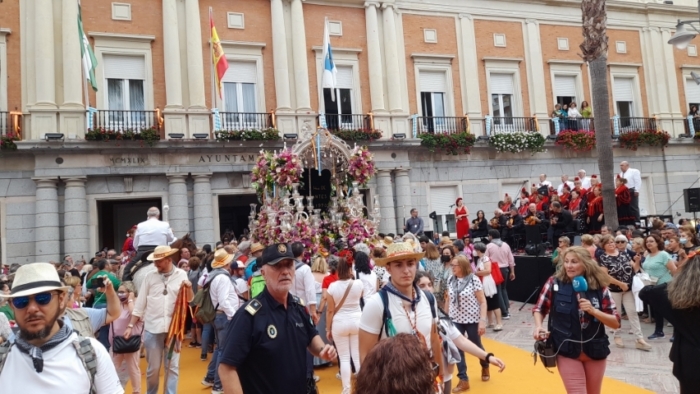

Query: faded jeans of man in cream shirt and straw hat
left=143, top=331, right=180, bottom=394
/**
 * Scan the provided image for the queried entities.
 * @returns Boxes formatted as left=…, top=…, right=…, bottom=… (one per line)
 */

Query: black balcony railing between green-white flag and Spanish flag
left=87, top=109, right=163, bottom=131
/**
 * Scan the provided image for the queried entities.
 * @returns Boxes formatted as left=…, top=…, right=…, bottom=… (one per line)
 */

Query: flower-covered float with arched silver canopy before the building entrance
left=248, top=123, right=380, bottom=254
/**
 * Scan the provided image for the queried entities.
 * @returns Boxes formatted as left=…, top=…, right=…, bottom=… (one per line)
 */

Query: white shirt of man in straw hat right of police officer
left=360, top=293, right=437, bottom=349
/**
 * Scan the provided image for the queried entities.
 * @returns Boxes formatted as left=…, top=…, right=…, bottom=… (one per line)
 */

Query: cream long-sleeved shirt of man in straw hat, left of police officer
left=133, top=268, right=187, bottom=334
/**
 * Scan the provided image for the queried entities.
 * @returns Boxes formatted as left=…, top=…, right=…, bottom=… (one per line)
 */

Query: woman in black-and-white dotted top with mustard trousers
left=445, top=255, right=491, bottom=393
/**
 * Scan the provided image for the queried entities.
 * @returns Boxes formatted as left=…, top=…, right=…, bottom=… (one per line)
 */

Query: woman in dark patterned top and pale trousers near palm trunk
left=599, top=234, right=651, bottom=352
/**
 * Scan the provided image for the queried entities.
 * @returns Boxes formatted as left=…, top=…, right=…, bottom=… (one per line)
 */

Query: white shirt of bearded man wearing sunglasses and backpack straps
left=0, top=333, right=124, bottom=394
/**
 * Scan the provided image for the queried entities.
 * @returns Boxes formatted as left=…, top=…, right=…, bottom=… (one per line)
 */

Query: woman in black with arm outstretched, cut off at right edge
left=639, top=255, right=700, bottom=394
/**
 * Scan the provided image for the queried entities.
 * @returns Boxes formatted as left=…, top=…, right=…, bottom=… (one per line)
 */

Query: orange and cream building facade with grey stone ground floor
left=0, top=0, right=700, bottom=263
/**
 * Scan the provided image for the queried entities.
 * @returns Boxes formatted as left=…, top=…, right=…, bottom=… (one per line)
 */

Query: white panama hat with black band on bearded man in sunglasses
left=0, top=263, right=69, bottom=298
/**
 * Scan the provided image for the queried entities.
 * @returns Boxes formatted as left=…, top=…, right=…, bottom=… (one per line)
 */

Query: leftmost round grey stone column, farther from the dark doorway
left=34, top=178, right=61, bottom=262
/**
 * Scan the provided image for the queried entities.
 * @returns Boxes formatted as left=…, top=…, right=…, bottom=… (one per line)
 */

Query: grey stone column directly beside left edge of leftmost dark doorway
left=63, top=177, right=90, bottom=261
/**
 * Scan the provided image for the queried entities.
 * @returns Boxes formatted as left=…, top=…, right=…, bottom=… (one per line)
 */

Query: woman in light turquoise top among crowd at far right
left=642, top=234, right=676, bottom=339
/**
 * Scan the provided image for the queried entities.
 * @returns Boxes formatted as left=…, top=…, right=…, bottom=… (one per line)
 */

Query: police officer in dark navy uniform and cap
left=219, top=244, right=336, bottom=394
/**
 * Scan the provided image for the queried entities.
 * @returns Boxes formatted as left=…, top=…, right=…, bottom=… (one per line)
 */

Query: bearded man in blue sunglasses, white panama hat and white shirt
left=0, top=263, right=124, bottom=394
